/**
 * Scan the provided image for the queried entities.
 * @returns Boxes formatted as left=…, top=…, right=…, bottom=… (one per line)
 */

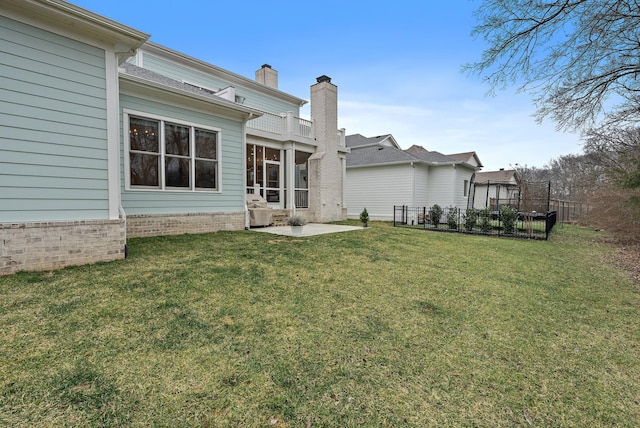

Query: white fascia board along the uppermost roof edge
left=141, top=42, right=308, bottom=107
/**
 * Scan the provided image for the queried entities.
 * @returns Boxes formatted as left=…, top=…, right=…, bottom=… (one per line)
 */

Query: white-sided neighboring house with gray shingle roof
left=345, top=134, right=482, bottom=220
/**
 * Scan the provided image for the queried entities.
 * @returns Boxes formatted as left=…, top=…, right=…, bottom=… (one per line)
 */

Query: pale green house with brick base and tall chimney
left=0, top=0, right=348, bottom=275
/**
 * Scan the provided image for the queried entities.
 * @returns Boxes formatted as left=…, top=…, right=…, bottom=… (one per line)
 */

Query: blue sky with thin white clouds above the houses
left=72, top=0, right=581, bottom=171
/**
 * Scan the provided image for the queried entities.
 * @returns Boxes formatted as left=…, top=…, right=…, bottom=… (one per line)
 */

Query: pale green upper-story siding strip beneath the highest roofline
left=142, top=53, right=300, bottom=116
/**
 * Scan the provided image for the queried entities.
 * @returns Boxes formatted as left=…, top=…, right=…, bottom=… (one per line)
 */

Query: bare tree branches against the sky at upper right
left=464, top=0, right=640, bottom=131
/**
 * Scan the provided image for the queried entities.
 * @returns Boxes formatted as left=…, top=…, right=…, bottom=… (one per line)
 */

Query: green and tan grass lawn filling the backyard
left=0, top=222, right=640, bottom=427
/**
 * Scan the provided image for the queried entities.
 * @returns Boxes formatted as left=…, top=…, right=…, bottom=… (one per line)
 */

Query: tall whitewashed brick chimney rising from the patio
left=309, top=75, right=346, bottom=222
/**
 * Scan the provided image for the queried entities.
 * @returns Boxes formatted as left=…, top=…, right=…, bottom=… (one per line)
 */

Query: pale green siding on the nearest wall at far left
left=0, top=16, right=108, bottom=222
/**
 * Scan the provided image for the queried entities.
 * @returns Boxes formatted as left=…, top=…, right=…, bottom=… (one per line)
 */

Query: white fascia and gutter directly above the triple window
left=120, top=73, right=263, bottom=122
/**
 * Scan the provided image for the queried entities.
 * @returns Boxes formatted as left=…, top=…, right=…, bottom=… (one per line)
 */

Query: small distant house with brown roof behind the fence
left=471, top=168, right=520, bottom=210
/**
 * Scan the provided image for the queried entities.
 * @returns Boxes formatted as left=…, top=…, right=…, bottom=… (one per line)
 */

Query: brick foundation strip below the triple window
left=127, top=212, right=245, bottom=238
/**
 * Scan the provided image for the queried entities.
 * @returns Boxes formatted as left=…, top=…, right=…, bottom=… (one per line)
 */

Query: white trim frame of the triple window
left=122, top=109, right=222, bottom=194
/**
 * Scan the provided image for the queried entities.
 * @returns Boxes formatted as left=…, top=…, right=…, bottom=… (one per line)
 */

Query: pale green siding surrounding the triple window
left=120, top=95, right=245, bottom=215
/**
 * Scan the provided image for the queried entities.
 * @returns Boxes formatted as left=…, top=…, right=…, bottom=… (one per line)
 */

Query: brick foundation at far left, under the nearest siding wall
left=0, top=220, right=125, bottom=276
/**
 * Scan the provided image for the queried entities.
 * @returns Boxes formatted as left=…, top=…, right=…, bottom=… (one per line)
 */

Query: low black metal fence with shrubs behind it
left=393, top=205, right=558, bottom=239
